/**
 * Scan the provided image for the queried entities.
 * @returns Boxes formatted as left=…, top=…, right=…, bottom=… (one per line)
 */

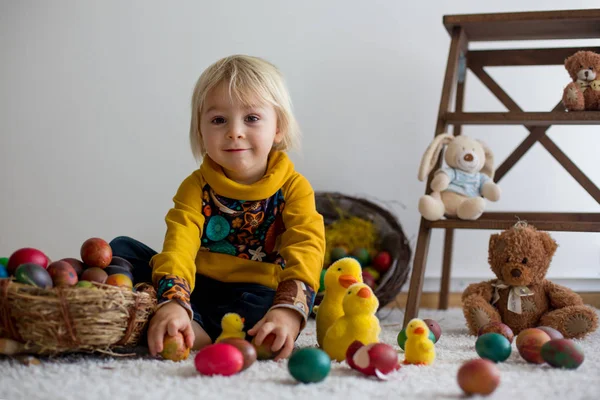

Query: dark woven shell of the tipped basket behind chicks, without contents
left=315, top=192, right=412, bottom=308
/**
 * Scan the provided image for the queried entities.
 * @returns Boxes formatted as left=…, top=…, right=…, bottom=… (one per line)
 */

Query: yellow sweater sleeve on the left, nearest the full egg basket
left=151, top=173, right=204, bottom=318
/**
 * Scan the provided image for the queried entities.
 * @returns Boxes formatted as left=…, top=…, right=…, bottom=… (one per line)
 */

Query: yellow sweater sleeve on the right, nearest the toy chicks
left=272, top=174, right=325, bottom=328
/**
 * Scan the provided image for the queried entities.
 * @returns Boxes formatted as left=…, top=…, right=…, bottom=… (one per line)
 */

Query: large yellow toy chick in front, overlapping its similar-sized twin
left=323, top=283, right=381, bottom=361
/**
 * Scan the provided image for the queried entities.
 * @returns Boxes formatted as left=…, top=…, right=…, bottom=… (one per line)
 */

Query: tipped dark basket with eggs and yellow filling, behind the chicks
left=315, top=192, right=411, bottom=307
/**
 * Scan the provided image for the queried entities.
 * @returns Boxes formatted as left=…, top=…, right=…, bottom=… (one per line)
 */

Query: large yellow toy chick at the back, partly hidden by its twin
left=314, top=257, right=363, bottom=347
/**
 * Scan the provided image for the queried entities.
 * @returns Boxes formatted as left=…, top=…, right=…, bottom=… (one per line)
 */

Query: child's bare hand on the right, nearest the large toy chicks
left=248, top=308, right=302, bottom=361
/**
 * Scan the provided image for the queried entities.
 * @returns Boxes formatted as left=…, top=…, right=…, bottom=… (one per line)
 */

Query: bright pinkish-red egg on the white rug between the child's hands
left=194, top=343, right=244, bottom=376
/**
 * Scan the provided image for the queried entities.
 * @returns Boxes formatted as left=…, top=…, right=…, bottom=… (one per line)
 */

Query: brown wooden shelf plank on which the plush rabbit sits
left=426, top=212, right=600, bottom=232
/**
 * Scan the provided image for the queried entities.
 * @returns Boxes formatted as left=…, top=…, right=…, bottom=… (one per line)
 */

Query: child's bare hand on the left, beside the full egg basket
left=148, top=301, right=194, bottom=356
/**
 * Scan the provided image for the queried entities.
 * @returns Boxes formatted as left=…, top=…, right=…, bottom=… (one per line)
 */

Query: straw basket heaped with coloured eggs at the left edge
left=0, top=238, right=156, bottom=355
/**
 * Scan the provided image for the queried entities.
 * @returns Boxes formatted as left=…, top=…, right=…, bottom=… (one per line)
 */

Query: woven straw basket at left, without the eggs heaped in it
left=0, top=279, right=156, bottom=355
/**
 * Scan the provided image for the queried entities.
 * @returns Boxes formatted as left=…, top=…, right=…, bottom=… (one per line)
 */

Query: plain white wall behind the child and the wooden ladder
left=0, top=0, right=600, bottom=290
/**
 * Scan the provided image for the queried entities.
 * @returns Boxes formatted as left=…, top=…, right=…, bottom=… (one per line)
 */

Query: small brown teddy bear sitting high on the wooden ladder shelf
left=563, top=51, right=600, bottom=111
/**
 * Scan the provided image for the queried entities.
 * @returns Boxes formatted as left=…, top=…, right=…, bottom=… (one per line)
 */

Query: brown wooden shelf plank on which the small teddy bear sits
left=444, top=111, right=600, bottom=126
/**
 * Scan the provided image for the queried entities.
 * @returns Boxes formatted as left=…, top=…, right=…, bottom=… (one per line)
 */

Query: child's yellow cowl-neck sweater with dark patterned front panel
left=151, top=152, right=325, bottom=324
